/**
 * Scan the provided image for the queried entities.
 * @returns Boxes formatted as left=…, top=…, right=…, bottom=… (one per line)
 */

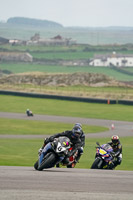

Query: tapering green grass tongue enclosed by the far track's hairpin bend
left=0, top=118, right=108, bottom=135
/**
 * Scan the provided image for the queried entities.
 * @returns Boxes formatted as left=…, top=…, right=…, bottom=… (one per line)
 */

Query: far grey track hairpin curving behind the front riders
left=0, top=112, right=133, bottom=138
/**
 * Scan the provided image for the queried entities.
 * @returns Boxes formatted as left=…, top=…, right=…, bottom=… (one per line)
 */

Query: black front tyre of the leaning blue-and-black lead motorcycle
left=38, top=152, right=57, bottom=171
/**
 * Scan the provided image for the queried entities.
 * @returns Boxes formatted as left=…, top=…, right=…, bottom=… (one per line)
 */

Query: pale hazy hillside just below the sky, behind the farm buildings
left=0, top=20, right=133, bottom=45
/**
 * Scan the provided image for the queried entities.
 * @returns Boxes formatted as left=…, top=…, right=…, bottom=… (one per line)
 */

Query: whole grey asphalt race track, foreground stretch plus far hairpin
left=0, top=112, right=133, bottom=200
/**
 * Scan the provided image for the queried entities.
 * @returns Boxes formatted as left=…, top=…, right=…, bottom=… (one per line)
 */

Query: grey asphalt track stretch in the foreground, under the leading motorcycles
left=0, top=166, right=133, bottom=200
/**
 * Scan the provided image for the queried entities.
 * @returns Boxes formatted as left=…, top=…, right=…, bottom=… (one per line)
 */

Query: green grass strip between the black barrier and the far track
left=0, top=95, right=133, bottom=121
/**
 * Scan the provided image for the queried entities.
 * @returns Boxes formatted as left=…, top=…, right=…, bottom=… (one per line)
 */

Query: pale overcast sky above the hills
left=0, top=0, right=133, bottom=27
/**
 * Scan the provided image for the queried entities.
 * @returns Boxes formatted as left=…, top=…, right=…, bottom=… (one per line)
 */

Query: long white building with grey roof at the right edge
left=89, top=52, right=133, bottom=67
